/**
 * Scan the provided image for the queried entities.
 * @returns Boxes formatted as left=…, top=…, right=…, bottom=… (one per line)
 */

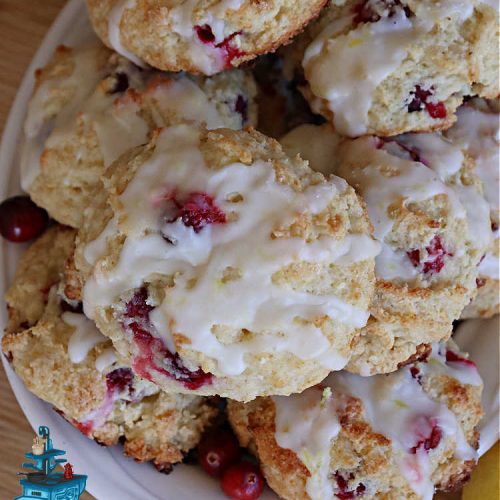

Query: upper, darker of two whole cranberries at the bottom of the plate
left=198, top=430, right=240, bottom=476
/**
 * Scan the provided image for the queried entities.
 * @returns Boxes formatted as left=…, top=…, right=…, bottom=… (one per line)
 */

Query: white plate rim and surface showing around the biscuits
left=0, top=0, right=499, bottom=500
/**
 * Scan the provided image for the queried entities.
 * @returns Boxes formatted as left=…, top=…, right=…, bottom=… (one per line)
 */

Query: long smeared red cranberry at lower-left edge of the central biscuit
left=122, top=287, right=213, bottom=390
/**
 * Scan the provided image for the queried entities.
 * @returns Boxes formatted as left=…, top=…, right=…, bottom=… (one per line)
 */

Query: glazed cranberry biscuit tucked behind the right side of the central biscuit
left=282, top=125, right=491, bottom=375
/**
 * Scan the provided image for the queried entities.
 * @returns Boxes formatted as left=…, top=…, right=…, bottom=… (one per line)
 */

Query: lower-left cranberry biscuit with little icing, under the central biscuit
left=2, top=227, right=217, bottom=470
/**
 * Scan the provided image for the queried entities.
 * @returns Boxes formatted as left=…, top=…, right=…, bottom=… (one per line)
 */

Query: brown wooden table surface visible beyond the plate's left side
left=0, top=0, right=496, bottom=500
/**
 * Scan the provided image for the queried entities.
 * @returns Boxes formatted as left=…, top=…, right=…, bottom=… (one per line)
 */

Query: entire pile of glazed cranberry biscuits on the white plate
left=2, top=0, right=500, bottom=500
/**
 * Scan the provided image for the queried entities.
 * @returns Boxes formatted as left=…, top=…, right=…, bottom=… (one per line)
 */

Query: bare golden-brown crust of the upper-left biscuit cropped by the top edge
left=87, top=0, right=327, bottom=74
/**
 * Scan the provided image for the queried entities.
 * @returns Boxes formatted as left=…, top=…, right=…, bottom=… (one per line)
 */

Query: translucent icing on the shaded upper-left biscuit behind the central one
left=21, top=43, right=243, bottom=197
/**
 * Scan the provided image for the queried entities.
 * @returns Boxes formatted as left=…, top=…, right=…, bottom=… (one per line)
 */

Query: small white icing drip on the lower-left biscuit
left=61, top=312, right=107, bottom=363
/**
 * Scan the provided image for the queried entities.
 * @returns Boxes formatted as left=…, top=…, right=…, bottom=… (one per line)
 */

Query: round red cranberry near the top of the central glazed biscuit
left=165, top=193, right=226, bottom=238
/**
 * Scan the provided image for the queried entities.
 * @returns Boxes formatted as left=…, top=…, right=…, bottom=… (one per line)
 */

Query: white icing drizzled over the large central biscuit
left=83, top=126, right=378, bottom=374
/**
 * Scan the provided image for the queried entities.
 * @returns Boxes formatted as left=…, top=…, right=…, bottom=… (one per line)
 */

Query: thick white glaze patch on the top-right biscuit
left=302, top=10, right=416, bottom=136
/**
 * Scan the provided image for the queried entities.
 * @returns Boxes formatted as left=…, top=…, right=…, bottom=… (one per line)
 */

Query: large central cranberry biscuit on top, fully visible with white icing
left=75, top=126, right=379, bottom=400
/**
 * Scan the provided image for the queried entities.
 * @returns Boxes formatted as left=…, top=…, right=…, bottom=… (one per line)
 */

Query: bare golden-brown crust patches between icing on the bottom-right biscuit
left=228, top=362, right=482, bottom=500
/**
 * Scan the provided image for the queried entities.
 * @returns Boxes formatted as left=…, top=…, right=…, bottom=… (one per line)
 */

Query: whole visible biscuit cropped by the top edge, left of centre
left=87, top=0, right=326, bottom=75
